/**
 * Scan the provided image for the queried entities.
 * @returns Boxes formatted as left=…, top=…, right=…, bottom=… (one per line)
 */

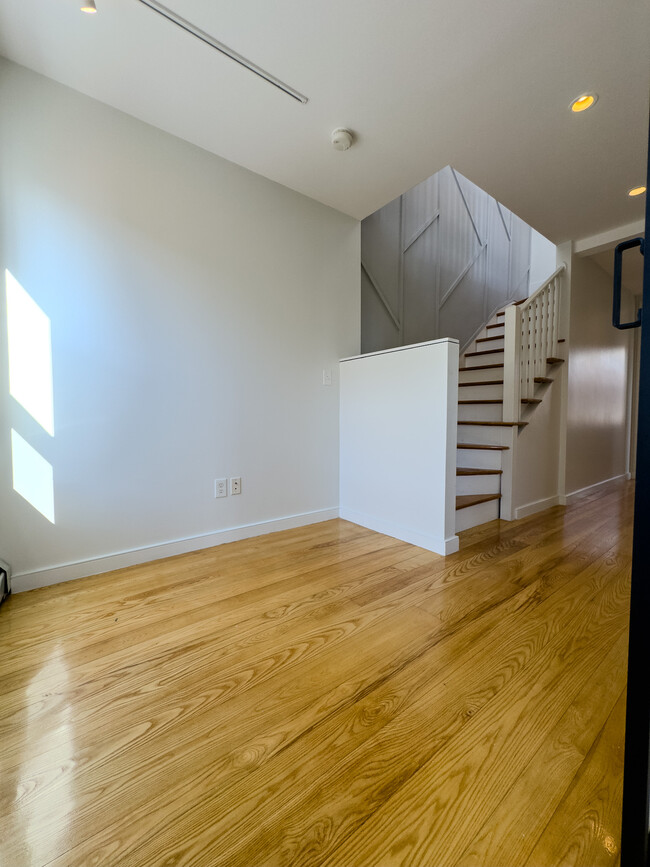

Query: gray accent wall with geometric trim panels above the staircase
left=361, top=166, right=537, bottom=352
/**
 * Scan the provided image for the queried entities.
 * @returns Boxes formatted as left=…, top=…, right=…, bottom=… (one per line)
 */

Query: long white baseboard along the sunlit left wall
left=11, top=509, right=339, bottom=593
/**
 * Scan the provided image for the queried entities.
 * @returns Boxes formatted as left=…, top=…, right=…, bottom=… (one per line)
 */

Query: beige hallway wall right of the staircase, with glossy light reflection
left=566, top=256, right=632, bottom=495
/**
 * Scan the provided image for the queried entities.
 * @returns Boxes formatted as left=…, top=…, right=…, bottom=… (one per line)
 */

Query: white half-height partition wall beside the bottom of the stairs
left=340, top=339, right=458, bottom=554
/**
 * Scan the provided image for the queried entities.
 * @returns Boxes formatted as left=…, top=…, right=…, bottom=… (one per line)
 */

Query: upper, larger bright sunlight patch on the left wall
left=5, top=271, right=54, bottom=436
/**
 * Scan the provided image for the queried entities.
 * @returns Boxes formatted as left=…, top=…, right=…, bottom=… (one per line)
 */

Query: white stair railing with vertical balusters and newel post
left=503, top=265, right=566, bottom=422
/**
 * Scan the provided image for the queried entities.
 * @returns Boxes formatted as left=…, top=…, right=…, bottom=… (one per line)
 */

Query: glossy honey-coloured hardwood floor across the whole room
left=0, top=483, right=633, bottom=867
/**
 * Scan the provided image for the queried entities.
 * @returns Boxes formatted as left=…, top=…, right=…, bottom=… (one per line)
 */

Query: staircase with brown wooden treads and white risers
left=456, top=299, right=564, bottom=532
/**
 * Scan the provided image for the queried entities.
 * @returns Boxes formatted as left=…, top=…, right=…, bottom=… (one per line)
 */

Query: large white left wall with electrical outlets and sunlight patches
left=0, top=61, right=360, bottom=590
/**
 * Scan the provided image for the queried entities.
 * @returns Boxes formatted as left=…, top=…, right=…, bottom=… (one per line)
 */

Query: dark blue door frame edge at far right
left=621, top=117, right=650, bottom=867
